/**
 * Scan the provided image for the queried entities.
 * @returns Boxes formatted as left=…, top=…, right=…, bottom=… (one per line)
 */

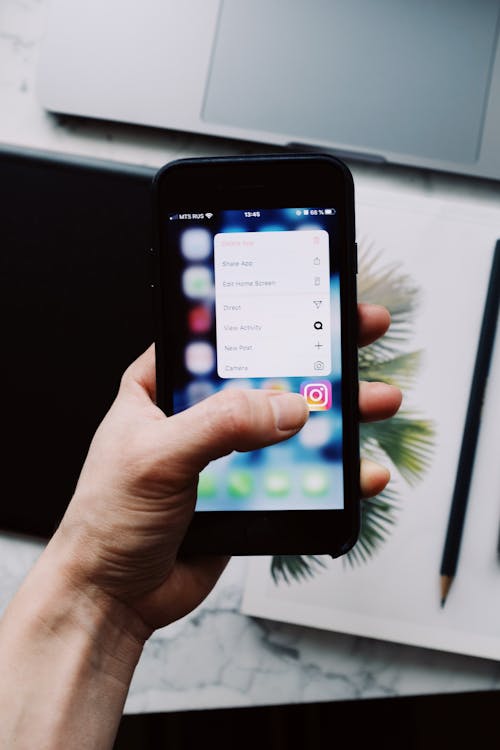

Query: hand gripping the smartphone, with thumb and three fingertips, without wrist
left=52, top=305, right=401, bottom=637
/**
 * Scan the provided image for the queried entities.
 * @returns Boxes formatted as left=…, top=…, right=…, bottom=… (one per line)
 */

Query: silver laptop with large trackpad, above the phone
left=38, top=0, right=500, bottom=179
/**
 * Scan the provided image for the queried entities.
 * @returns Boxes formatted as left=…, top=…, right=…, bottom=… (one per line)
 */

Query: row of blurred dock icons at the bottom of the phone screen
left=198, top=466, right=331, bottom=500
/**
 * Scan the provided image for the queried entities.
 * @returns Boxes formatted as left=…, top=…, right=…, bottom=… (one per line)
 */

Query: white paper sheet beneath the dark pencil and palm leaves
left=242, top=189, right=500, bottom=659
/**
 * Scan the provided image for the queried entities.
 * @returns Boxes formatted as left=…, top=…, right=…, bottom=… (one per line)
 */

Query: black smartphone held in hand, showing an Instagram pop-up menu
left=153, top=154, right=360, bottom=557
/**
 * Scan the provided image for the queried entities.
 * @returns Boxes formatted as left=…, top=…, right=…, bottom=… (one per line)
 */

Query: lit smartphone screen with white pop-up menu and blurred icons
left=166, top=205, right=344, bottom=513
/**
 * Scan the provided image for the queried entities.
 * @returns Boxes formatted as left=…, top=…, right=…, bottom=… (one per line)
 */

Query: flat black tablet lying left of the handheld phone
left=0, top=149, right=153, bottom=537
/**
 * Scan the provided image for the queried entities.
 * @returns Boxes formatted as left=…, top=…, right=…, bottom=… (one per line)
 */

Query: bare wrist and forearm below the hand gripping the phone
left=0, top=538, right=147, bottom=750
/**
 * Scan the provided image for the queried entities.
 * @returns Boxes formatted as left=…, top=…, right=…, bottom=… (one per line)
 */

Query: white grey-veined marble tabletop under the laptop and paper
left=0, top=0, right=500, bottom=713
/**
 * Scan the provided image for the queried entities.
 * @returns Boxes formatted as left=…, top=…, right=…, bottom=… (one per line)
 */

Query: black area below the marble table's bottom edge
left=114, top=692, right=500, bottom=750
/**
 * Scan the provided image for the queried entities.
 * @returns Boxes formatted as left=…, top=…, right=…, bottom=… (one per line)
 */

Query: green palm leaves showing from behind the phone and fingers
left=271, top=244, right=435, bottom=583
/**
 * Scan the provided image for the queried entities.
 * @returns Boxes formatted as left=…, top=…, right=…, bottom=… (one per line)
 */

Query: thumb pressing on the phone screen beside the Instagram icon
left=156, top=388, right=309, bottom=475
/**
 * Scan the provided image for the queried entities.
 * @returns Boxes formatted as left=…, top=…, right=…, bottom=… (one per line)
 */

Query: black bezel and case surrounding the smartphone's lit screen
left=153, top=154, right=360, bottom=557
